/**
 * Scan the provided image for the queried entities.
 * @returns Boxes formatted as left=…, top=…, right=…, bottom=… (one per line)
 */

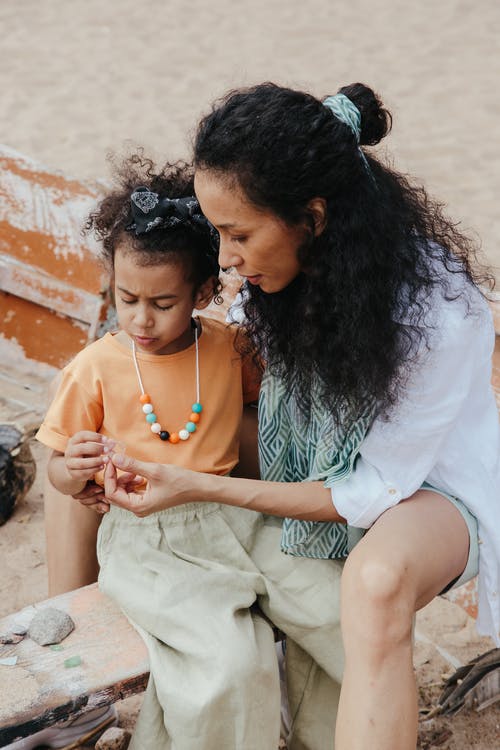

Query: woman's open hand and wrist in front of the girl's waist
left=104, top=453, right=210, bottom=518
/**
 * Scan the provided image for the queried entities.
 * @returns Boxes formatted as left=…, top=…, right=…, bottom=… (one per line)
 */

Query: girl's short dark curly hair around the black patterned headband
left=84, top=149, right=222, bottom=304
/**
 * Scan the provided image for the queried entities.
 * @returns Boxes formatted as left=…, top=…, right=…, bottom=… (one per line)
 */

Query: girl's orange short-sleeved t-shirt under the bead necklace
left=36, top=318, right=260, bottom=474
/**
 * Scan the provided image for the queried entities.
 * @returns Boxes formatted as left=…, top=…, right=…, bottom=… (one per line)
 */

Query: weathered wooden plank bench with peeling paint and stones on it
left=0, top=584, right=149, bottom=747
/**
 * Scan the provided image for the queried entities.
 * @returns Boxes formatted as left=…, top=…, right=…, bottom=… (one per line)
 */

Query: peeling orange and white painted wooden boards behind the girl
left=0, top=146, right=108, bottom=366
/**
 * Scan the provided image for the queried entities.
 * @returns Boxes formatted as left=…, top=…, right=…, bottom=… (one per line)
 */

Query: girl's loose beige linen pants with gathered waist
left=98, top=503, right=343, bottom=750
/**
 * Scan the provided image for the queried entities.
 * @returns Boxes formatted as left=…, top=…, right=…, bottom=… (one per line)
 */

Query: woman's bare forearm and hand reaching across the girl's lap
left=104, top=454, right=344, bottom=523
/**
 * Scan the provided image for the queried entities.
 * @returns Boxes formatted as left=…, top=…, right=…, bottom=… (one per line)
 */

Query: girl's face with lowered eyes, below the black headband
left=114, top=242, right=211, bottom=354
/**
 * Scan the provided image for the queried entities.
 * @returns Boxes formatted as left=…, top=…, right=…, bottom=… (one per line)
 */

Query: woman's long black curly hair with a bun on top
left=194, top=83, right=490, bottom=422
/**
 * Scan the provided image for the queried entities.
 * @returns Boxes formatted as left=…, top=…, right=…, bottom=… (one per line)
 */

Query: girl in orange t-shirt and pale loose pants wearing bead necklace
left=38, top=157, right=341, bottom=750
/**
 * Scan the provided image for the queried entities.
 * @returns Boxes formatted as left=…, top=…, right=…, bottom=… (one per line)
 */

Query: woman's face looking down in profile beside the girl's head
left=194, top=169, right=308, bottom=293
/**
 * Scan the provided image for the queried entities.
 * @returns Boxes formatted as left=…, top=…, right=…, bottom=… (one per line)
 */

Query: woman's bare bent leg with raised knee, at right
left=335, top=490, right=469, bottom=750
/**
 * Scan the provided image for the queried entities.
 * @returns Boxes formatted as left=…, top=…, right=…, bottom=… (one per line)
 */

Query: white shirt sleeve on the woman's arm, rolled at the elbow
left=331, top=303, right=484, bottom=528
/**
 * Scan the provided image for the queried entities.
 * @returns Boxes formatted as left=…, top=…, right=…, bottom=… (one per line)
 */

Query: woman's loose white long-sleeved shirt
left=332, top=274, right=500, bottom=645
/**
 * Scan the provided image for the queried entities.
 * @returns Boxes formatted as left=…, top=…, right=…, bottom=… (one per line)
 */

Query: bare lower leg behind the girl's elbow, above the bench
left=44, top=468, right=101, bottom=596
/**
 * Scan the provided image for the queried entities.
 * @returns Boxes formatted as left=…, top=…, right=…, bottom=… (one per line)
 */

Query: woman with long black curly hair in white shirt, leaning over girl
left=77, top=84, right=500, bottom=750
